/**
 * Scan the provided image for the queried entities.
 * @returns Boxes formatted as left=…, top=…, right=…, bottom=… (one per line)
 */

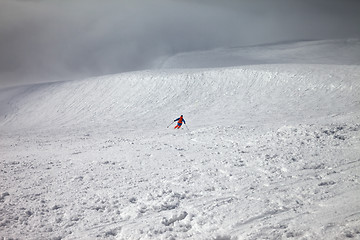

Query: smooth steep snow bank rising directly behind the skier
left=0, top=65, right=360, bottom=132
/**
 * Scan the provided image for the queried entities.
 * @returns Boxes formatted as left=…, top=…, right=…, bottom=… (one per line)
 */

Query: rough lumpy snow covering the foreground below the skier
left=0, top=124, right=360, bottom=239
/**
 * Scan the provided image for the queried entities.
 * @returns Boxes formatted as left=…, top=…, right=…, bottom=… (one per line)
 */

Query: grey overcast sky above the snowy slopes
left=0, top=0, right=360, bottom=88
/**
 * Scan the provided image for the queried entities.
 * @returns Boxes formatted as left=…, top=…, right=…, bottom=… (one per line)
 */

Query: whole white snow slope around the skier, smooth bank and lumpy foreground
left=0, top=41, right=360, bottom=240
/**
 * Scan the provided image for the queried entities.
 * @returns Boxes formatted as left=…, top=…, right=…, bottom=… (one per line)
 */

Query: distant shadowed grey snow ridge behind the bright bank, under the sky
left=161, top=39, right=360, bottom=68
